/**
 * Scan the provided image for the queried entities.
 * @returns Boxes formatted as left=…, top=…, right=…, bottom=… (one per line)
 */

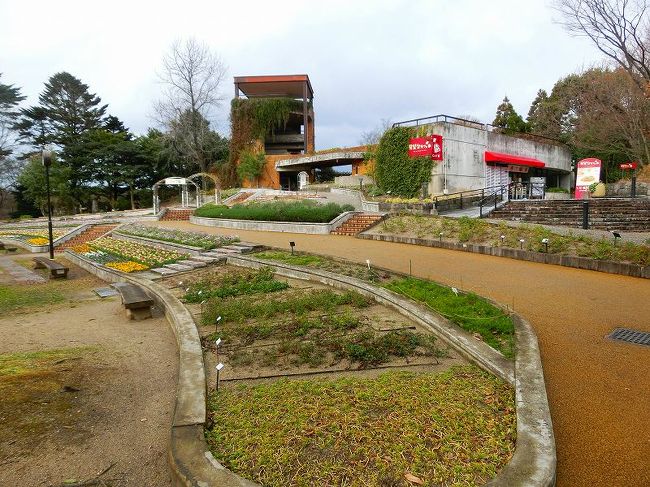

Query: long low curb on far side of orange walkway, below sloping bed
left=357, top=233, right=650, bottom=279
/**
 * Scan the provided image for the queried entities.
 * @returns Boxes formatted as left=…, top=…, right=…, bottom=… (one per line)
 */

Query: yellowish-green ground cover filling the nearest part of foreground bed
left=206, top=366, right=516, bottom=487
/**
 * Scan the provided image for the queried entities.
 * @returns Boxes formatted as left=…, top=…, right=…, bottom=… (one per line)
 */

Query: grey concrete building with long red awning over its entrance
left=395, top=115, right=571, bottom=195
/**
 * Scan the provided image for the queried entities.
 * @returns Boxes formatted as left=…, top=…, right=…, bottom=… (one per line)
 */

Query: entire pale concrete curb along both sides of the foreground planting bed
left=65, top=251, right=556, bottom=487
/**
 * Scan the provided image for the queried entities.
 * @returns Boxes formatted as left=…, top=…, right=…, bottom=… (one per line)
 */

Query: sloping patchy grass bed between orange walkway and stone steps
left=377, top=215, right=650, bottom=265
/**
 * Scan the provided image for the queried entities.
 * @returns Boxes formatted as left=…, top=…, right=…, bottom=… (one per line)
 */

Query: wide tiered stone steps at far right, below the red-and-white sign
left=490, top=198, right=650, bottom=232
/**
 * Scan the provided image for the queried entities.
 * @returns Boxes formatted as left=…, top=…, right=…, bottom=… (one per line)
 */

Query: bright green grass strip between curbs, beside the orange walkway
left=385, top=277, right=515, bottom=359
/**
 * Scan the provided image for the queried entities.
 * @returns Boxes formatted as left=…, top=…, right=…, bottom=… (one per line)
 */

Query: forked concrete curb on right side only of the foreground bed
left=228, top=256, right=556, bottom=487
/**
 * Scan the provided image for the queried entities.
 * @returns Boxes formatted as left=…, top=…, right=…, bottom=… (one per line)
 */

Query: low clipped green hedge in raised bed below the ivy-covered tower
left=194, top=201, right=354, bottom=223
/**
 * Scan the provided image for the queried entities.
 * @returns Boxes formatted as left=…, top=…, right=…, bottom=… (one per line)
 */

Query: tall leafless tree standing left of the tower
left=154, top=39, right=227, bottom=172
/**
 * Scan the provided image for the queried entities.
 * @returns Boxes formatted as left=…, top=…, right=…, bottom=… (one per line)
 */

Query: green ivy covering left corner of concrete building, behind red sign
left=374, top=127, right=433, bottom=198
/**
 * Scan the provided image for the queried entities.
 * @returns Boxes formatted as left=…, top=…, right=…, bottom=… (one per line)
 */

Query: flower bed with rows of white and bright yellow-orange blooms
left=70, top=237, right=185, bottom=272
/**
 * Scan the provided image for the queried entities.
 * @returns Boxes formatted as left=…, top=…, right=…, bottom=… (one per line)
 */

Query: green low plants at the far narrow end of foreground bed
left=183, top=267, right=289, bottom=303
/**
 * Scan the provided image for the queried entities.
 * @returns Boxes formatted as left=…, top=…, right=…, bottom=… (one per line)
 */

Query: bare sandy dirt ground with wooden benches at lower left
left=0, top=258, right=178, bottom=487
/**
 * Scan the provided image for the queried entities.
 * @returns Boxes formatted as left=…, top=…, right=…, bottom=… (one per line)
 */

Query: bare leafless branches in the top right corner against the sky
left=554, top=0, right=650, bottom=92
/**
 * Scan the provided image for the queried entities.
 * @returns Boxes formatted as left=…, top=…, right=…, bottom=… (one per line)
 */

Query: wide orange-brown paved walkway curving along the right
left=153, top=222, right=650, bottom=487
